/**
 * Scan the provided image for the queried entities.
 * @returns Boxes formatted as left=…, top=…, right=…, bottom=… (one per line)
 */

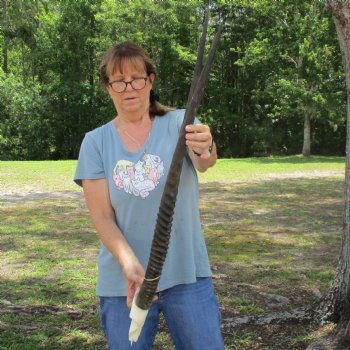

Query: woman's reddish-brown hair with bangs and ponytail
left=100, top=42, right=172, bottom=118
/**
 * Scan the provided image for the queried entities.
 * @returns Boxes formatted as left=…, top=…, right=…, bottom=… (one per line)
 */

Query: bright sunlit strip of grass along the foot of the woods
left=0, top=156, right=345, bottom=193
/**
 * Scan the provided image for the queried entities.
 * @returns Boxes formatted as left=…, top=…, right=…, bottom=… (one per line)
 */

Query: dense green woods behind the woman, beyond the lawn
left=0, top=0, right=346, bottom=160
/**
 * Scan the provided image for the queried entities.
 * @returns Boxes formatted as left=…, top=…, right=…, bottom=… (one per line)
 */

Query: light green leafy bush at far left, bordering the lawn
left=0, top=68, right=52, bottom=160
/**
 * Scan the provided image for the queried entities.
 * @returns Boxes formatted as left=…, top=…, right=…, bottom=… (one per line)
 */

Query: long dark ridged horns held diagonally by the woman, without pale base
left=136, top=11, right=222, bottom=310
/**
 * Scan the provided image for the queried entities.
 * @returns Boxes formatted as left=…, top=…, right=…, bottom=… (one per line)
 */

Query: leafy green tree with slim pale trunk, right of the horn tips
left=228, top=0, right=342, bottom=156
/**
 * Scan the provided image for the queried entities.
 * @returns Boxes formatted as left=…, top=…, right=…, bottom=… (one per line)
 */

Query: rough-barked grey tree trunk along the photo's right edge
left=308, top=0, right=350, bottom=349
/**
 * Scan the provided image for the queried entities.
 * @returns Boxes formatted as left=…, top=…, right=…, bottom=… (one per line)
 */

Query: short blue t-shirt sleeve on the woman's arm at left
left=74, top=133, right=105, bottom=186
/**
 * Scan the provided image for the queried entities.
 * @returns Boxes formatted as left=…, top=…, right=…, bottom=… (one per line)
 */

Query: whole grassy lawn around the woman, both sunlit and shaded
left=0, top=156, right=344, bottom=350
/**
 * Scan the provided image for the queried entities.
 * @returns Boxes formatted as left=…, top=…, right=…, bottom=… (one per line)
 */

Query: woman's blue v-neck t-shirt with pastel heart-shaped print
left=74, top=110, right=211, bottom=296
